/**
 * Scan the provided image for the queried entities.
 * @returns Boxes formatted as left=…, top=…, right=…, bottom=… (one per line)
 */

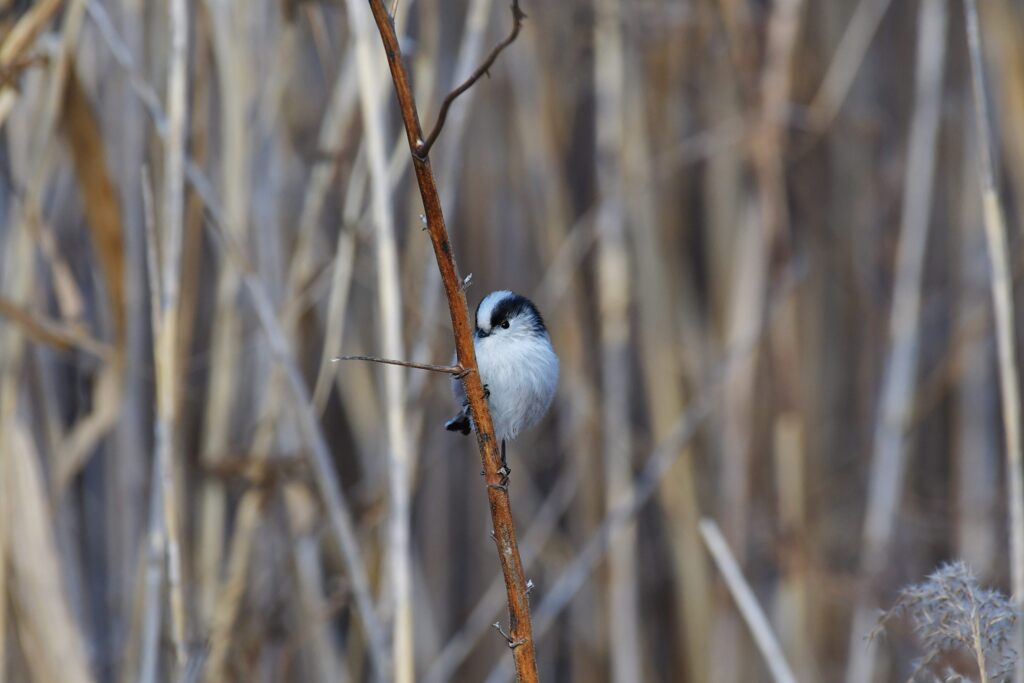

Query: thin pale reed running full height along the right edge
left=964, top=0, right=1024, bottom=683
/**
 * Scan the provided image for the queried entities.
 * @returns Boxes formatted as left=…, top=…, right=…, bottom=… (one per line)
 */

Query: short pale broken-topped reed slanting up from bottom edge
left=700, top=519, right=797, bottom=683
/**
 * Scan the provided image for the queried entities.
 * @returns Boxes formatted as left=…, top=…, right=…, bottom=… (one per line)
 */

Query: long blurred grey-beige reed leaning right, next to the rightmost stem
left=846, top=0, right=946, bottom=683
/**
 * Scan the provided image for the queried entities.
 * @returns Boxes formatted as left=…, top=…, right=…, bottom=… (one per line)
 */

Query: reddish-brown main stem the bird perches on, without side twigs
left=370, top=0, right=538, bottom=683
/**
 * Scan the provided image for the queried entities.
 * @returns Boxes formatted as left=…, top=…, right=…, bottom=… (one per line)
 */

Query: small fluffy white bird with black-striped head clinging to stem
left=444, top=290, right=558, bottom=477
